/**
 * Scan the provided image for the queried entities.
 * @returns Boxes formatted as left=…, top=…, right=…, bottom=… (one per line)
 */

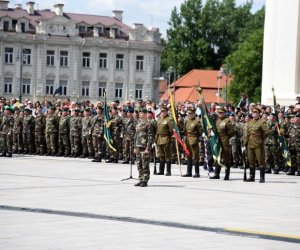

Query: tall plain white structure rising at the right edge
left=262, top=0, right=300, bottom=105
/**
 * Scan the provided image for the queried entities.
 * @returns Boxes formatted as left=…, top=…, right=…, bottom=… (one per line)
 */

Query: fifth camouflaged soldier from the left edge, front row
left=45, top=106, right=59, bottom=156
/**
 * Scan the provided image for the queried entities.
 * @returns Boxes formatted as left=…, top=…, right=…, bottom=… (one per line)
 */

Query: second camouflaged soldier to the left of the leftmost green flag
left=80, top=108, right=94, bottom=159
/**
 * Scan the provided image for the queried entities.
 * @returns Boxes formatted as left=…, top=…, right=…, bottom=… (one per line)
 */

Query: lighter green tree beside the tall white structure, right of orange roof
left=226, top=29, right=264, bottom=103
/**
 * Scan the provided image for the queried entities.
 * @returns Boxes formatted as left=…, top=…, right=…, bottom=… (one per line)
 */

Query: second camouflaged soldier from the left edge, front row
left=13, top=107, right=23, bottom=154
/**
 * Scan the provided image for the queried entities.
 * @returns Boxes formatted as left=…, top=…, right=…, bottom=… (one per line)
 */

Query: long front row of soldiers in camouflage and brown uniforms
left=0, top=101, right=300, bottom=185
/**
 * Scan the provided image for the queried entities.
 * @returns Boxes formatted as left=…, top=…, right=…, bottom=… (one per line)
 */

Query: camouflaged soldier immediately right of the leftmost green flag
left=107, top=107, right=122, bottom=163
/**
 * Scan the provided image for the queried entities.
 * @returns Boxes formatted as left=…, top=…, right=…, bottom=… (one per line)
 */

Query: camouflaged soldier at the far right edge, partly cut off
left=287, top=113, right=300, bottom=176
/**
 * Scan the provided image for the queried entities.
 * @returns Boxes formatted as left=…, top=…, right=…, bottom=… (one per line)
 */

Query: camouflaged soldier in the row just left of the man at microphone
left=122, top=107, right=137, bottom=164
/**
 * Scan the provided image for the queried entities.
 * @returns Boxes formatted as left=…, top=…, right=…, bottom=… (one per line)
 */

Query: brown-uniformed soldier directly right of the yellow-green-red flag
left=183, top=108, right=203, bottom=178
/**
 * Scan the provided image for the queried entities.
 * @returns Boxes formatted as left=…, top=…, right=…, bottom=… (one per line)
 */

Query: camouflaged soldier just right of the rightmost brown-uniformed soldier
left=265, top=113, right=281, bottom=174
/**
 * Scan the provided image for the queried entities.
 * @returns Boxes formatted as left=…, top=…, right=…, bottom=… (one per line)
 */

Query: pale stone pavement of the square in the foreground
left=0, top=155, right=300, bottom=250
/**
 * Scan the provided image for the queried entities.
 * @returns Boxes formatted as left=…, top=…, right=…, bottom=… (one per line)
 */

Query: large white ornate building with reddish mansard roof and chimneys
left=0, top=0, right=162, bottom=102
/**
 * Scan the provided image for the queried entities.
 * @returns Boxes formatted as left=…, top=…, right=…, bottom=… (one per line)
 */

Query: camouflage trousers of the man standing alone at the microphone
left=135, top=147, right=150, bottom=182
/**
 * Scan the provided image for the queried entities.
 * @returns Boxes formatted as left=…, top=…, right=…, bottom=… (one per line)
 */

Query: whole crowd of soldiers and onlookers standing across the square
left=0, top=95, right=300, bottom=187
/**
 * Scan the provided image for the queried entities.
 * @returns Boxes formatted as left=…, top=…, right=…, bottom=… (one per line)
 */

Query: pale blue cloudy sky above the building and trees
left=9, top=0, right=265, bottom=37
